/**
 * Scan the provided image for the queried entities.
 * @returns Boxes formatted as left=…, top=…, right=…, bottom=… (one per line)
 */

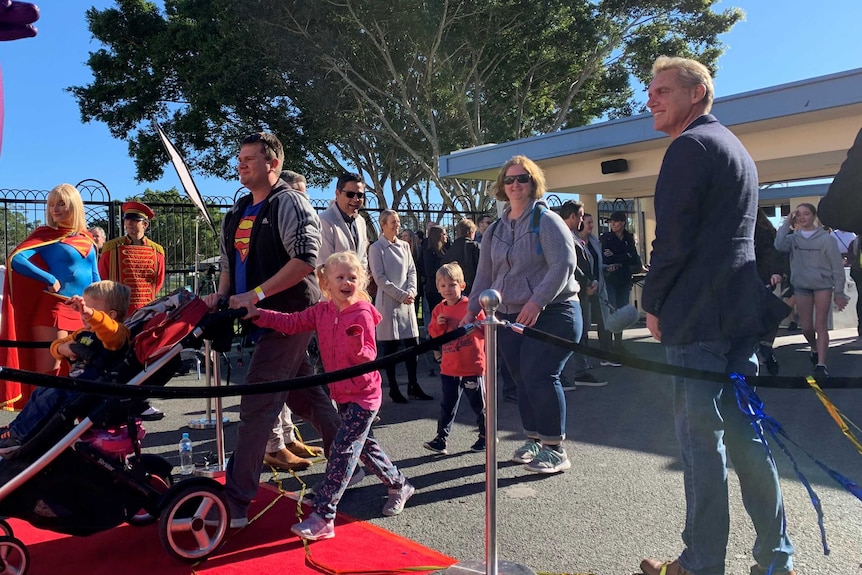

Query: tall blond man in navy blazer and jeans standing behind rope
left=641, top=56, right=793, bottom=575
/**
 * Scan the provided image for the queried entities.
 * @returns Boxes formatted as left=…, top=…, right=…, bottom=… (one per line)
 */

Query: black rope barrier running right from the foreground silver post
left=520, top=323, right=862, bottom=389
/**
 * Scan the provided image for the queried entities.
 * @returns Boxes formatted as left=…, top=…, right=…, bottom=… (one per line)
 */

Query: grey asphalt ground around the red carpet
left=0, top=328, right=862, bottom=575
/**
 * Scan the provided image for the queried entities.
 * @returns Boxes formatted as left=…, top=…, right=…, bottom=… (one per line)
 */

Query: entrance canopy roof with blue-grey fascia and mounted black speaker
left=440, top=68, right=862, bottom=198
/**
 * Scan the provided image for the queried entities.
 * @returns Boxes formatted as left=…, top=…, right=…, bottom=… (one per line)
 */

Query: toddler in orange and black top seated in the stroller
left=0, top=280, right=131, bottom=458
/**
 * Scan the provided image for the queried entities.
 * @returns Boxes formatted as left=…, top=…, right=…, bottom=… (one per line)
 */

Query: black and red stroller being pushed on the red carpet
left=0, top=290, right=236, bottom=575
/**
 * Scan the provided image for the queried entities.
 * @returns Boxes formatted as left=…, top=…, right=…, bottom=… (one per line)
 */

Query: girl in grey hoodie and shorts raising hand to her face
left=775, top=204, right=848, bottom=377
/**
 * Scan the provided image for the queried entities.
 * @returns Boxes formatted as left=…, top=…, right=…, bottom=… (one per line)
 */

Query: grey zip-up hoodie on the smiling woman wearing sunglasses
left=468, top=200, right=580, bottom=314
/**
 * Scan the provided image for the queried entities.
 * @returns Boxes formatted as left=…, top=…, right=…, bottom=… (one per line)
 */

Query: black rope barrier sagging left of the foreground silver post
left=0, top=324, right=474, bottom=399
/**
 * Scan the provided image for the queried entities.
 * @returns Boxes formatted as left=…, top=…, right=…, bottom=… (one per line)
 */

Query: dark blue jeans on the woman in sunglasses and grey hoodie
left=497, top=301, right=582, bottom=443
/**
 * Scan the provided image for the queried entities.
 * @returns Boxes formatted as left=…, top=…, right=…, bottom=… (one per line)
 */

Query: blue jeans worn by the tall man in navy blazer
left=665, top=337, right=793, bottom=575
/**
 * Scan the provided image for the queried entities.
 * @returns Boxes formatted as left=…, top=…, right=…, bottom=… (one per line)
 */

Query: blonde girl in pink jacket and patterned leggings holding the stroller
left=247, top=252, right=414, bottom=541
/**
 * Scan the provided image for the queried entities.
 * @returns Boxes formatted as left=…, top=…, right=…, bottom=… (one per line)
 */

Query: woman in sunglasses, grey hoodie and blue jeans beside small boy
left=461, top=156, right=583, bottom=473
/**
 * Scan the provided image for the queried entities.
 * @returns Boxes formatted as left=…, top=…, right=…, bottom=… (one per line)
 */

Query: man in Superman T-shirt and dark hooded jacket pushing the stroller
left=205, top=133, right=340, bottom=528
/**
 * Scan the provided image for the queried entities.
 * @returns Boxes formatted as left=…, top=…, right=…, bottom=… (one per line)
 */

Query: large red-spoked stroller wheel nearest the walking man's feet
left=159, top=479, right=230, bottom=563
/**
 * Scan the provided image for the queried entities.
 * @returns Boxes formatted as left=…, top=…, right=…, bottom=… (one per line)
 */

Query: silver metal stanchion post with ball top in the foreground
left=445, top=290, right=536, bottom=575
